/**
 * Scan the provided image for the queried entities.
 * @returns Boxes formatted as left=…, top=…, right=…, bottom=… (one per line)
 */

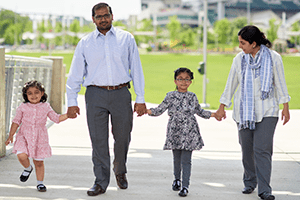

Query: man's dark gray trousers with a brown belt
left=85, top=86, right=133, bottom=189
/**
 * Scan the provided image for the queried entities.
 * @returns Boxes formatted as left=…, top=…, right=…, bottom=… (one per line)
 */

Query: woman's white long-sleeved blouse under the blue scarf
left=220, top=50, right=291, bottom=123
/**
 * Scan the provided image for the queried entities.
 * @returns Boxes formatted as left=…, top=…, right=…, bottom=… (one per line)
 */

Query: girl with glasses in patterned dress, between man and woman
left=147, top=68, right=217, bottom=197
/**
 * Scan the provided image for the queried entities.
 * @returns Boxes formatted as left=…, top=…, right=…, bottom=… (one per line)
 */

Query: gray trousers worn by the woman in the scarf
left=239, top=117, right=278, bottom=194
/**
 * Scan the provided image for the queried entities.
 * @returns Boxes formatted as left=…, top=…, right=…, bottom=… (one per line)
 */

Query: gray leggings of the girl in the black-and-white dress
left=172, top=149, right=192, bottom=188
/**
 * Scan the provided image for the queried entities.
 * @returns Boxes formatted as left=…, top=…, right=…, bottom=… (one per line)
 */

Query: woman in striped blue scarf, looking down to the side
left=216, top=26, right=290, bottom=200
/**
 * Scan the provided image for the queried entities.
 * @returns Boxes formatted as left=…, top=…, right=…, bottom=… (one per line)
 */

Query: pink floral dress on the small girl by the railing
left=13, top=102, right=60, bottom=159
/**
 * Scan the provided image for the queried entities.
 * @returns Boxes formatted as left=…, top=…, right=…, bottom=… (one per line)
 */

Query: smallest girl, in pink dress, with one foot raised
left=5, top=80, right=68, bottom=192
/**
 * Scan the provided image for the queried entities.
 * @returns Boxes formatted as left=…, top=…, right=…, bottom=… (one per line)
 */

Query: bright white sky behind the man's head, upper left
left=0, top=0, right=141, bottom=20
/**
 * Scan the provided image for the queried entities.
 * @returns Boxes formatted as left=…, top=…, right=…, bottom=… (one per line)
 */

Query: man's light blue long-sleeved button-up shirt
left=67, top=26, right=145, bottom=107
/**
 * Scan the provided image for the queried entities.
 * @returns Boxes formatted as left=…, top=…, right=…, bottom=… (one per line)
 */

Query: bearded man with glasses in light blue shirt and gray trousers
left=67, top=3, right=146, bottom=196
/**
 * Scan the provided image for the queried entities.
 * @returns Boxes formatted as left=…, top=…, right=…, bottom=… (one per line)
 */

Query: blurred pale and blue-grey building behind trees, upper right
left=137, top=0, right=300, bottom=27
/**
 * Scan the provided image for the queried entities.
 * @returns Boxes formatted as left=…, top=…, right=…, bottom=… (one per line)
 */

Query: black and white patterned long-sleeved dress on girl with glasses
left=150, top=91, right=211, bottom=151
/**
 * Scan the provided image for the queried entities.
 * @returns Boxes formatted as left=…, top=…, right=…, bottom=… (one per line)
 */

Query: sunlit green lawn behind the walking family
left=10, top=52, right=300, bottom=109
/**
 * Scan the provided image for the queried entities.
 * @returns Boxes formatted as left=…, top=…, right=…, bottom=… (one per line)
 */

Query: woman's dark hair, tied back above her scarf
left=238, top=25, right=272, bottom=48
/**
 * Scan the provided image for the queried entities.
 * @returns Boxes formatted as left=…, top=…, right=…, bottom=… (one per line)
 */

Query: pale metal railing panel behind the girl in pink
left=5, top=55, right=53, bottom=134
